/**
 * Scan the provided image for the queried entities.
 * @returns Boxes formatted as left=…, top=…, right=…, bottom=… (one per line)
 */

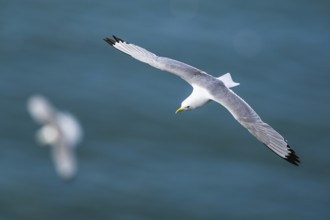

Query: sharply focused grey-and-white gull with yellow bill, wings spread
left=104, top=35, right=300, bottom=166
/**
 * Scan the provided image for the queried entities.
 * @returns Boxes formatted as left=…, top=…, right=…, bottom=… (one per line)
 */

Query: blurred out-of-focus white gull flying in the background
left=27, top=95, right=82, bottom=180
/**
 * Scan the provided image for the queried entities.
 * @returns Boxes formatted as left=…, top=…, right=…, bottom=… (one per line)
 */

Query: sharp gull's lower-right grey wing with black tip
left=213, top=89, right=300, bottom=166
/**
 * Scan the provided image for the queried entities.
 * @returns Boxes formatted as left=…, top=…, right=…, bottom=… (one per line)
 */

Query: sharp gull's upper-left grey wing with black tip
left=104, top=36, right=206, bottom=84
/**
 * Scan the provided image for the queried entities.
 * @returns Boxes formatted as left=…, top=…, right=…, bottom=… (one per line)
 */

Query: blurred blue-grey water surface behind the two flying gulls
left=0, top=0, right=330, bottom=220
